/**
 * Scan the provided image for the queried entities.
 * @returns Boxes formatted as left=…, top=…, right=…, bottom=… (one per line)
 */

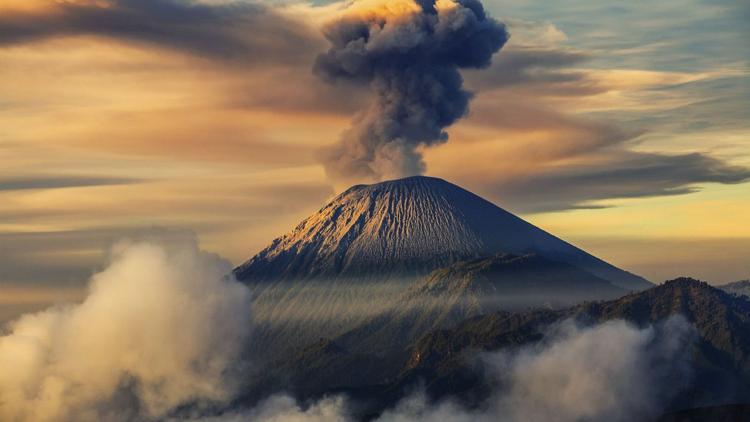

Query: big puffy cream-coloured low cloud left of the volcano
left=0, top=239, right=252, bottom=422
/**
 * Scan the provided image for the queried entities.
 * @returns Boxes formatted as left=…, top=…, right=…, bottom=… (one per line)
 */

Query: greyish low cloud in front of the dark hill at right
left=482, top=316, right=694, bottom=422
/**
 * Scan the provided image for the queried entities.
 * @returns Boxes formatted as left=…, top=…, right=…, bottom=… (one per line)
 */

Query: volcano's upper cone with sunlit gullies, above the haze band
left=235, top=176, right=651, bottom=290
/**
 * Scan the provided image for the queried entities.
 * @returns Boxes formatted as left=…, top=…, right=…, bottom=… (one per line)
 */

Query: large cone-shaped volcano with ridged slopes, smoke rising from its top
left=235, top=177, right=651, bottom=359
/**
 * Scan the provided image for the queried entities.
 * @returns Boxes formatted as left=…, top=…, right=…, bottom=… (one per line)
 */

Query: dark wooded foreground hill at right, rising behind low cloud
left=402, top=278, right=750, bottom=407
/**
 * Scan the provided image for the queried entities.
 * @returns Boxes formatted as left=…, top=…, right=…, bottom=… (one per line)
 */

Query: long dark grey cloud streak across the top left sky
left=0, top=0, right=318, bottom=65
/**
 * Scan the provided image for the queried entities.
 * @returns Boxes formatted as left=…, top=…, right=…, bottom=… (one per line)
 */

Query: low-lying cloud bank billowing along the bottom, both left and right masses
left=0, top=239, right=694, bottom=422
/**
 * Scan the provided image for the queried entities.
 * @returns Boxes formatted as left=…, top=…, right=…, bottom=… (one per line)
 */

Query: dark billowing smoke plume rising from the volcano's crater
left=314, top=0, right=508, bottom=182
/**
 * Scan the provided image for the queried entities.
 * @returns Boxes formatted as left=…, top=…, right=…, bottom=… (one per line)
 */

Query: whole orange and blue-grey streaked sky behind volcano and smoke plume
left=0, top=0, right=750, bottom=319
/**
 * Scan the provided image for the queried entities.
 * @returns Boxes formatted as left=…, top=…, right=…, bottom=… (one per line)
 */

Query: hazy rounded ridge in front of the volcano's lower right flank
left=336, top=254, right=627, bottom=355
